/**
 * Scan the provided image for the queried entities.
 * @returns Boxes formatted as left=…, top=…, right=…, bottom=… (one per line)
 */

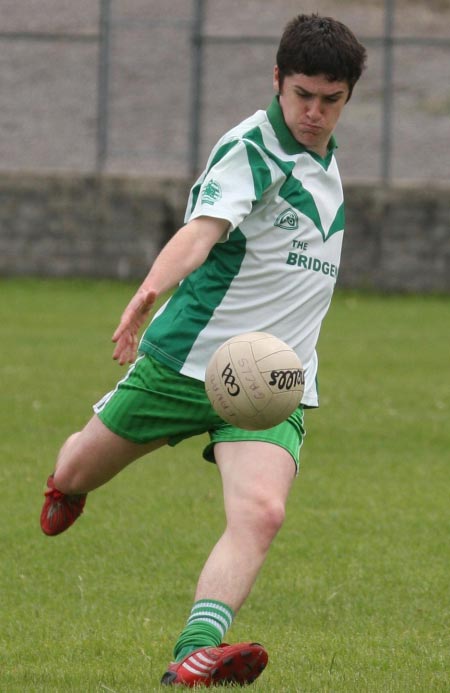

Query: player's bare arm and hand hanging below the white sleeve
left=112, top=216, right=230, bottom=366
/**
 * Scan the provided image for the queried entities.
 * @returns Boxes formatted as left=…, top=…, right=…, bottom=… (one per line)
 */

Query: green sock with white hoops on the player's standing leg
left=173, top=599, right=234, bottom=662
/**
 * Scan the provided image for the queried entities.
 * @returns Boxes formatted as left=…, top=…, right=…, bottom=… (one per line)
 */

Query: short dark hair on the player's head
left=277, top=14, right=367, bottom=98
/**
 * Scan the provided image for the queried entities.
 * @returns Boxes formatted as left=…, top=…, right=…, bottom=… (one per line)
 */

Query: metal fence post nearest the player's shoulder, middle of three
left=189, top=0, right=205, bottom=177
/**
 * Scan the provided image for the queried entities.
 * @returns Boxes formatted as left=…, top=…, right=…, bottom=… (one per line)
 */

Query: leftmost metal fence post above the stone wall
left=96, top=0, right=111, bottom=173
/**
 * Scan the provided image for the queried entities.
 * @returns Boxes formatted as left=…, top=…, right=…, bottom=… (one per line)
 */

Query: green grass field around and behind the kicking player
left=0, top=280, right=450, bottom=693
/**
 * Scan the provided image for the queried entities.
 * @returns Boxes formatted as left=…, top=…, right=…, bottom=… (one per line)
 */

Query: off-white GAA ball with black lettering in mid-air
left=205, top=332, right=305, bottom=431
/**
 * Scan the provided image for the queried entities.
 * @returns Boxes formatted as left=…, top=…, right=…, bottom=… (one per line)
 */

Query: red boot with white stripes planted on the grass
left=161, top=642, right=268, bottom=688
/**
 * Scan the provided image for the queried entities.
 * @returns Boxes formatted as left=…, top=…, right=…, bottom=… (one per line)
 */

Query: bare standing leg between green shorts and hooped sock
left=195, top=441, right=295, bottom=613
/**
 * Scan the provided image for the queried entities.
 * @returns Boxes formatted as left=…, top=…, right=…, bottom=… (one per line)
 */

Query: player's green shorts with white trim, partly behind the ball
left=94, top=354, right=305, bottom=470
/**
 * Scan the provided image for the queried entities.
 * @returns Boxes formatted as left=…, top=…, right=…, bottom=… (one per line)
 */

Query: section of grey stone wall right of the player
left=339, top=185, right=450, bottom=293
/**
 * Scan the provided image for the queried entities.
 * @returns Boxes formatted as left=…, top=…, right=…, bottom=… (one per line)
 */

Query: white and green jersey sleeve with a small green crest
left=186, top=139, right=268, bottom=231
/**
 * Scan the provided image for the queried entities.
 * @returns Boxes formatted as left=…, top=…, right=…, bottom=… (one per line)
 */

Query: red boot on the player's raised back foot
left=41, top=474, right=87, bottom=536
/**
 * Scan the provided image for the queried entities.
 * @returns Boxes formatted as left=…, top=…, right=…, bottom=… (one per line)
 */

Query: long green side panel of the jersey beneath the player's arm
left=140, top=228, right=246, bottom=370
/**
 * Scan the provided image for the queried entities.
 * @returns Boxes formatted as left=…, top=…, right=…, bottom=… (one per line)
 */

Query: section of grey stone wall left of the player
left=0, top=174, right=188, bottom=279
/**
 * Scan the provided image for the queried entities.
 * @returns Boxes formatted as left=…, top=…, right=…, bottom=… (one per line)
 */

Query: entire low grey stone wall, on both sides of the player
left=0, top=174, right=450, bottom=292
